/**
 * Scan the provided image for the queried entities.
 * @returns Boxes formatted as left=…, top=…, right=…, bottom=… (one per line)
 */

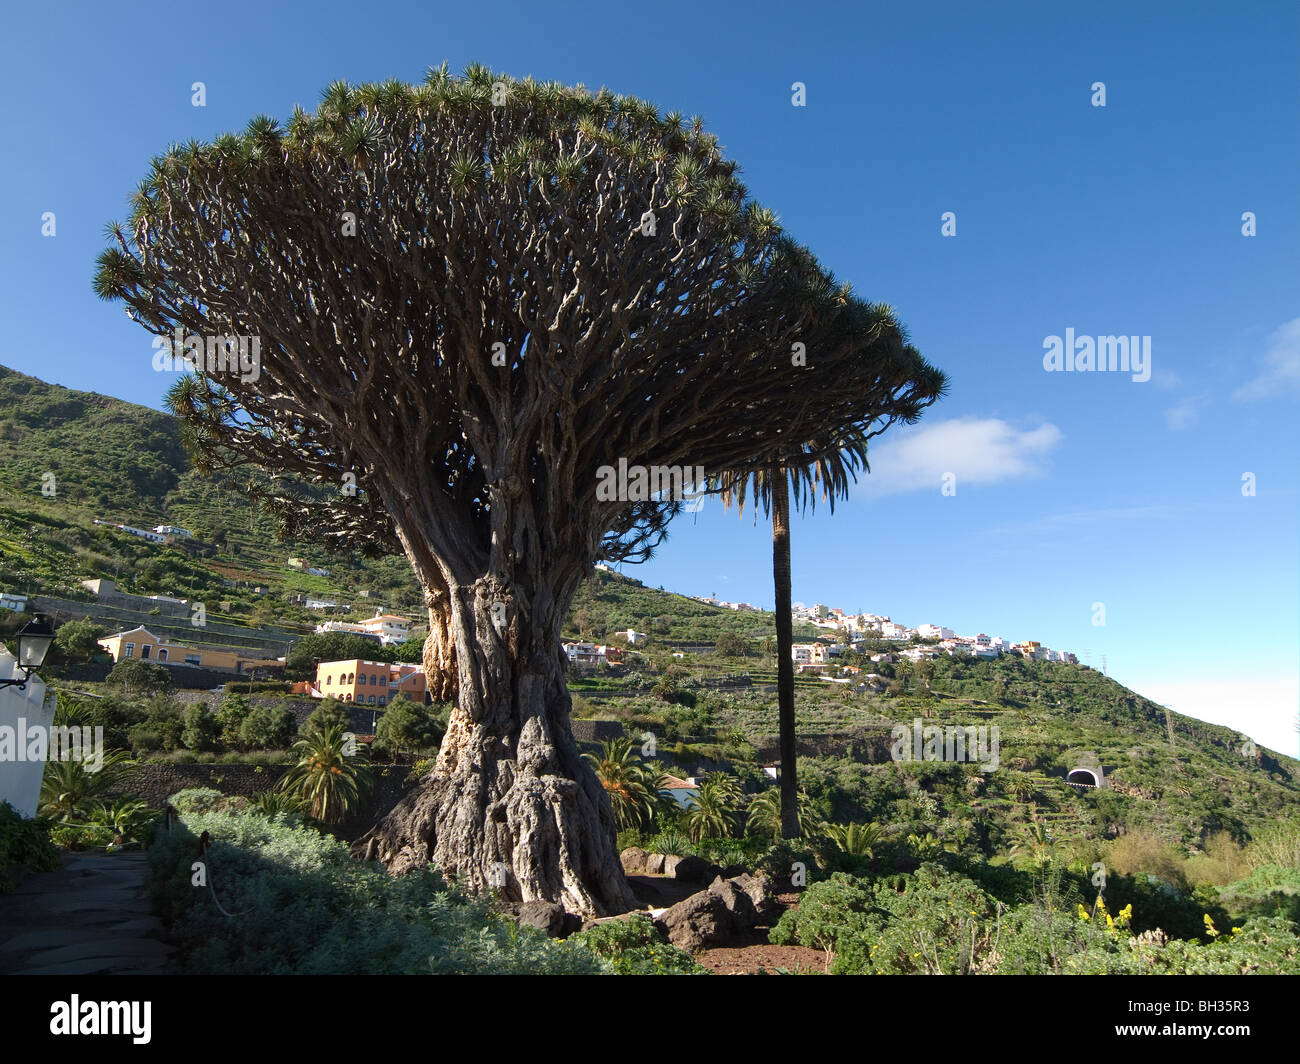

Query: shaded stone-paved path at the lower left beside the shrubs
left=0, top=853, right=176, bottom=976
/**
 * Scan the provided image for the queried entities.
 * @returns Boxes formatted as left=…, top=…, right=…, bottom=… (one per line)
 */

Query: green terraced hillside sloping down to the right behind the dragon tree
left=0, top=368, right=1300, bottom=848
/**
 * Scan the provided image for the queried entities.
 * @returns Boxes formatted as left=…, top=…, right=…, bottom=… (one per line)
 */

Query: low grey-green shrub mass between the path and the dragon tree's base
left=150, top=792, right=605, bottom=974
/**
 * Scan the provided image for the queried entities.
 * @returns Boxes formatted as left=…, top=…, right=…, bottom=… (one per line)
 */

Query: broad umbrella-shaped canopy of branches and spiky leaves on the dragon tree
left=96, top=66, right=939, bottom=621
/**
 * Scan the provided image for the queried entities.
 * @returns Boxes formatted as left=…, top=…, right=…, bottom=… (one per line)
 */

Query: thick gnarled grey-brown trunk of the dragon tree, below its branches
left=354, top=579, right=636, bottom=916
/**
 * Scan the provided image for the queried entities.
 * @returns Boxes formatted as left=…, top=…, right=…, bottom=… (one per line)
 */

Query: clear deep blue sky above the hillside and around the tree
left=0, top=0, right=1300, bottom=753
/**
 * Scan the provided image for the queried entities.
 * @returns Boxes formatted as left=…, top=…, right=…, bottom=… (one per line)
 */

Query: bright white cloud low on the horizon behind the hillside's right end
left=1123, top=676, right=1300, bottom=757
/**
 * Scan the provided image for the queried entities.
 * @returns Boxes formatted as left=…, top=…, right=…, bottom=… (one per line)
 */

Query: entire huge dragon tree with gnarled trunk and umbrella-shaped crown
left=95, top=65, right=943, bottom=914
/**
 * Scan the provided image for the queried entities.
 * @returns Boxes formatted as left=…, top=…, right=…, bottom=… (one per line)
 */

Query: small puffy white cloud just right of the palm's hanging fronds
left=858, top=418, right=1063, bottom=497
